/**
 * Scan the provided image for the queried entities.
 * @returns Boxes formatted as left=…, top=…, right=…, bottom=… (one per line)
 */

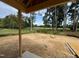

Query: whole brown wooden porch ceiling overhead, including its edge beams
left=1, top=0, right=69, bottom=13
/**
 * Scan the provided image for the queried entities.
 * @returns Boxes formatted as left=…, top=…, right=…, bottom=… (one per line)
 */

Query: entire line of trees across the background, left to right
left=0, top=1, right=79, bottom=31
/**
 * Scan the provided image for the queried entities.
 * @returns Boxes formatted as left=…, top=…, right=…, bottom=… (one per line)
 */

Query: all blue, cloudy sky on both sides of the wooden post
left=0, top=1, right=46, bottom=25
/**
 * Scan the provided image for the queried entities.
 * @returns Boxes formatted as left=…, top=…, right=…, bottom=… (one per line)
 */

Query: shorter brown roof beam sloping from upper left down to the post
left=1, top=0, right=26, bottom=12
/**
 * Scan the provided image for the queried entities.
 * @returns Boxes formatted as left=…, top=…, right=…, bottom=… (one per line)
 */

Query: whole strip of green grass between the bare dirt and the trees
left=0, top=28, right=79, bottom=37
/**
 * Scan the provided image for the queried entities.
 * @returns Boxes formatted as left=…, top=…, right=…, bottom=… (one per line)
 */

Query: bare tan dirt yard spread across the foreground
left=0, top=33, right=79, bottom=58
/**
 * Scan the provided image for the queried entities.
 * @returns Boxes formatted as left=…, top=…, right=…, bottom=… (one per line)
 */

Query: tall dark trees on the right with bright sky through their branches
left=43, top=1, right=79, bottom=31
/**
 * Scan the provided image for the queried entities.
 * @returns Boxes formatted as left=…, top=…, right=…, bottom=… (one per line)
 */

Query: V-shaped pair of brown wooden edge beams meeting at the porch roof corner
left=1, top=0, right=69, bottom=13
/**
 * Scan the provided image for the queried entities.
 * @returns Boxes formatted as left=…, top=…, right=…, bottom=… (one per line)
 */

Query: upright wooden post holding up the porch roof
left=18, top=10, right=22, bottom=57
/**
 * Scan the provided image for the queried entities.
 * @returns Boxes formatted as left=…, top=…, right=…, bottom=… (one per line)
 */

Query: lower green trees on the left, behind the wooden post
left=0, top=13, right=35, bottom=29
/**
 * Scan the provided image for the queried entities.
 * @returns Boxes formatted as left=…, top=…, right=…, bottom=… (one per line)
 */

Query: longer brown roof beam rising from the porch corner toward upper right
left=26, top=0, right=69, bottom=13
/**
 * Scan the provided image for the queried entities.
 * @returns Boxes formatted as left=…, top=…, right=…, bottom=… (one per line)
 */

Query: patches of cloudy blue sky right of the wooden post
left=22, top=9, right=47, bottom=26
